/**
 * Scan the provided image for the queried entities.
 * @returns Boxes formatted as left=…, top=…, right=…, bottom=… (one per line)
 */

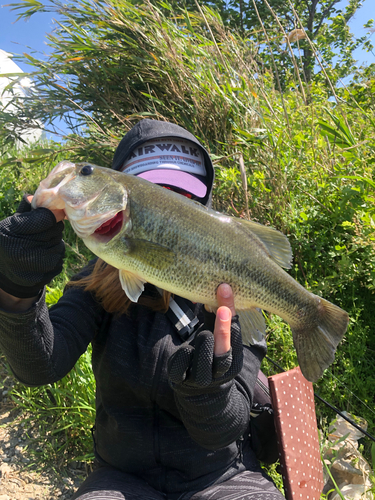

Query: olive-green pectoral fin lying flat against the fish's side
left=124, top=238, right=175, bottom=269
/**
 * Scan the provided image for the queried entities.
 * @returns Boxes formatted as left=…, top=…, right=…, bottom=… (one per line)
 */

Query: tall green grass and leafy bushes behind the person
left=0, top=0, right=375, bottom=494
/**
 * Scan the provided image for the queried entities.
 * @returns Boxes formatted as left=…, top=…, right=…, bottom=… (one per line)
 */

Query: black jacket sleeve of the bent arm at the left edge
left=0, top=287, right=103, bottom=386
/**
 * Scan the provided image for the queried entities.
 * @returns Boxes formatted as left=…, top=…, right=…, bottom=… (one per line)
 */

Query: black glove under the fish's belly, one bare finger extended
left=168, top=316, right=243, bottom=396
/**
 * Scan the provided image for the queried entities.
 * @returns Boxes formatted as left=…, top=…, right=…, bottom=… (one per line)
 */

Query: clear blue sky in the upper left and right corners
left=0, top=0, right=375, bottom=71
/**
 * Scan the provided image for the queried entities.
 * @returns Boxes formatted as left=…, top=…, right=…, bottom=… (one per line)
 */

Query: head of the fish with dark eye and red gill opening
left=32, top=161, right=128, bottom=241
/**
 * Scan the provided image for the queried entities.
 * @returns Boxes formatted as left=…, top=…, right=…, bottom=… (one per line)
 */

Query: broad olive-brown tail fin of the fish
left=292, top=299, right=349, bottom=382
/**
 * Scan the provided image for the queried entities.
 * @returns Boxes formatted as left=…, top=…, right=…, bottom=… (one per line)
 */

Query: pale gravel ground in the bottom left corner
left=0, top=359, right=86, bottom=500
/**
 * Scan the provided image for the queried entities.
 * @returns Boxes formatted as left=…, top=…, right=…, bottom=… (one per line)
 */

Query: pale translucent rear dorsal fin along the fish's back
left=236, top=219, right=293, bottom=269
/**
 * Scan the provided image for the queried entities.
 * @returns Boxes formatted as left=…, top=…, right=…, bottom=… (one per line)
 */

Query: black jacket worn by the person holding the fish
left=0, top=280, right=265, bottom=498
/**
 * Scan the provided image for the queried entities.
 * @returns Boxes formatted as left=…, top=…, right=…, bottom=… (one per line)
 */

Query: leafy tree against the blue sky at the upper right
left=172, top=0, right=373, bottom=88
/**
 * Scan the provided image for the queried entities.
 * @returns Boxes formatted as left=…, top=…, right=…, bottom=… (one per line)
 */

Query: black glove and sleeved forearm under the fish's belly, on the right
left=168, top=316, right=250, bottom=449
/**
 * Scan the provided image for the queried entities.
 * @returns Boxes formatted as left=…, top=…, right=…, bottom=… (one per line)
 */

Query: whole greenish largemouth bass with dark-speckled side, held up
left=32, top=161, right=349, bottom=382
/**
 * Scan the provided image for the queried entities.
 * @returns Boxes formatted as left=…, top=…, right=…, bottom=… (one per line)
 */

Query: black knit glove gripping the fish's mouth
left=0, top=195, right=65, bottom=299
